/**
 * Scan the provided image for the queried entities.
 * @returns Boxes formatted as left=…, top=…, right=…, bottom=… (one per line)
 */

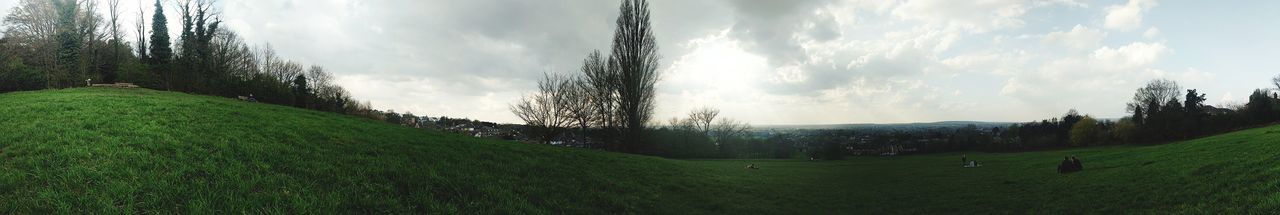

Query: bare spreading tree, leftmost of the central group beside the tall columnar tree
left=511, top=74, right=573, bottom=143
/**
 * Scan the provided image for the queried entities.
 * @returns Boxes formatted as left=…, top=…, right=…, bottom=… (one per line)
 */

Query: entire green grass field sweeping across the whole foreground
left=0, top=88, right=1280, bottom=214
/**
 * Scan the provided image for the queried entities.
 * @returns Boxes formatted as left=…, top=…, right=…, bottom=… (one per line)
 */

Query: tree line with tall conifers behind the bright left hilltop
left=0, top=0, right=371, bottom=115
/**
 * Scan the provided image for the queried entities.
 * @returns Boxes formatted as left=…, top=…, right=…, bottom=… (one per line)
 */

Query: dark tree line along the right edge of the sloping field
left=988, top=76, right=1280, bottom=151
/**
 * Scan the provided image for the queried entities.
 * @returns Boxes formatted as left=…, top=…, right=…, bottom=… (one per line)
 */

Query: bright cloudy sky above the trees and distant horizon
left=0, top=0, right=1280, bottom=124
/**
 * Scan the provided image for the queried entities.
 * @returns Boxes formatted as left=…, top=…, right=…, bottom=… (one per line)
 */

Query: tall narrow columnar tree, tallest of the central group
left=609, top=0, right=658, bottom=151
